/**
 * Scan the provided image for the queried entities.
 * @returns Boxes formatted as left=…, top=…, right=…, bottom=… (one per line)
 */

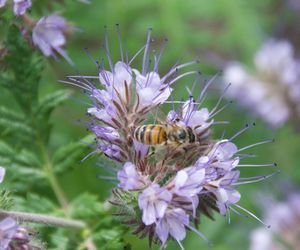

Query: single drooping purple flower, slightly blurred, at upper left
left=32, top=15, right=73, bottom=65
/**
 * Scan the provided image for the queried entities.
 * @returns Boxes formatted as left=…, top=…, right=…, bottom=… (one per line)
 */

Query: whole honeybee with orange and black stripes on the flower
left=132, top=124, right=196, bottom=145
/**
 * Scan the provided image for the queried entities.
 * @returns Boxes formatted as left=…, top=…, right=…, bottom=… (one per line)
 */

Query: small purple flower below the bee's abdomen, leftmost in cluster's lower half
left=117, top=162, right=150, bottom=190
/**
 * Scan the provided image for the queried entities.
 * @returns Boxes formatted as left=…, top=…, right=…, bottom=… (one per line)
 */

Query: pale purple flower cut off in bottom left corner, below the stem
left=0, top=217, right=19, bottom=250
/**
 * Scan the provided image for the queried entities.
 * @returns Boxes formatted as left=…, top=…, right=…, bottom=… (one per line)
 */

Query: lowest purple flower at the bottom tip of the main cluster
left=155, top=208, right=189, bottom=245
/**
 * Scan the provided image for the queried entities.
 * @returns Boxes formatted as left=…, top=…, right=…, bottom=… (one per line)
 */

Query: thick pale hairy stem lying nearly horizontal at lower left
left=0, top=210, right=86, bottom=229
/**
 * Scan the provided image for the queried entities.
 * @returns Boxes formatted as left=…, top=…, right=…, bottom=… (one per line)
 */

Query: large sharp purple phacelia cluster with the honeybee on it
left=65, top=28, right=276, bottom=249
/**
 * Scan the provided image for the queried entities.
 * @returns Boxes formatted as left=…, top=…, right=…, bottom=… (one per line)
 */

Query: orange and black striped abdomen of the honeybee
left=133, top=125, right=167, bottom=145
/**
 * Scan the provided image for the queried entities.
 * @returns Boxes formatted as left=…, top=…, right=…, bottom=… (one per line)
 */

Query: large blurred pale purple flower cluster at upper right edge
left=224, top=40, right=300, bottom=128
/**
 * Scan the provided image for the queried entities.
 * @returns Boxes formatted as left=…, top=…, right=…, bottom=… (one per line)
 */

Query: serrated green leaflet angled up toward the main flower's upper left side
left=35, top=89, right=72, bottom=116
